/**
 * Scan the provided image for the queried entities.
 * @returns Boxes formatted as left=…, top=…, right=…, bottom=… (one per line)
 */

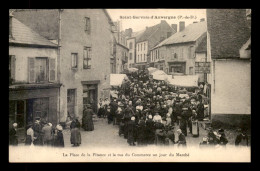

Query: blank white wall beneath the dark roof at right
left=211, top=59, right=251, bottom=114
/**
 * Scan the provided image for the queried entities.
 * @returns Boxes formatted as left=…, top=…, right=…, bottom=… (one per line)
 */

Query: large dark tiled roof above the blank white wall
left=207, top=9, right=251, bottom=59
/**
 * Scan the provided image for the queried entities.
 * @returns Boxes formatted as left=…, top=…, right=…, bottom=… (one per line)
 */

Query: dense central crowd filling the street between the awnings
left=98, top=71, right=208, bottom=145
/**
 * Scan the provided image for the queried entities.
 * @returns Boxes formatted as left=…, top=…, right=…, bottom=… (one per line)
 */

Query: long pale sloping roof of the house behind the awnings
left=154, top=21, right=207, bottom=48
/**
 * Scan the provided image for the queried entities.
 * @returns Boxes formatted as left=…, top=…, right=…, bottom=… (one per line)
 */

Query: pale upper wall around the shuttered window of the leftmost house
left=9, top=46, right=57, bottom=83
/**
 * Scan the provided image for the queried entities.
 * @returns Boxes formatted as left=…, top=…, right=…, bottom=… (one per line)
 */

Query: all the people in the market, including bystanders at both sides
left=9, top=71, right=248, bottom=147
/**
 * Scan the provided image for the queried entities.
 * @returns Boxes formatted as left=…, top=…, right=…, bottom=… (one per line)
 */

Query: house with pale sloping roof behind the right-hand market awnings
left=151, top=20, right=207, bottom=78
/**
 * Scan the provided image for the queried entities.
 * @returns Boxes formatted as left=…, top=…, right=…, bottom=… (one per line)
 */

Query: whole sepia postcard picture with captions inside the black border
left=9, top=8, right=251, bottom=163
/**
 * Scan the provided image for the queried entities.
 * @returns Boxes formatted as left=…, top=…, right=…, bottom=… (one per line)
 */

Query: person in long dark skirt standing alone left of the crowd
left=70, top=118, right=81, bottom=147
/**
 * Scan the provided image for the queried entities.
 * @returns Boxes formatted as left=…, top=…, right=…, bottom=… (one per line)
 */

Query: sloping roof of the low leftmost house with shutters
left=9, top=17, right=57, bottom=47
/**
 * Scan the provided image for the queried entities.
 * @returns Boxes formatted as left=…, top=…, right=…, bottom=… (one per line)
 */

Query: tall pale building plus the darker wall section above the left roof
left=13, top=9, right=114, bottom=122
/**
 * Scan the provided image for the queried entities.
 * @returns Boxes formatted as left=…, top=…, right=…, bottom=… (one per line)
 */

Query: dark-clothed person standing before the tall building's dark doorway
left=82, top=104, right=94, bottom=131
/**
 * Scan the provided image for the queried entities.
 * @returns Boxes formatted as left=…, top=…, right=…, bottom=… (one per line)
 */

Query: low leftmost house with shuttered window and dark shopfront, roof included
left=9, top=14, right=61, bottom=142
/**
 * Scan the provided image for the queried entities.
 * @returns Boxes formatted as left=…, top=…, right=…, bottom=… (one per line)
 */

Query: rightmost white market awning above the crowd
left=168, top=75, right=199, bottom=87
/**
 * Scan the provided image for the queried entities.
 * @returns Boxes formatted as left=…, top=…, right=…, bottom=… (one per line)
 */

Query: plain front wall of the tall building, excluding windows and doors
left=60, top=9, right=112, bottom=122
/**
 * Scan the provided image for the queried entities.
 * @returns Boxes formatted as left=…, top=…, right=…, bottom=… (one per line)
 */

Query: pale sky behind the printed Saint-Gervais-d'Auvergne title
left=107, top=9, right=206, bottom=32
